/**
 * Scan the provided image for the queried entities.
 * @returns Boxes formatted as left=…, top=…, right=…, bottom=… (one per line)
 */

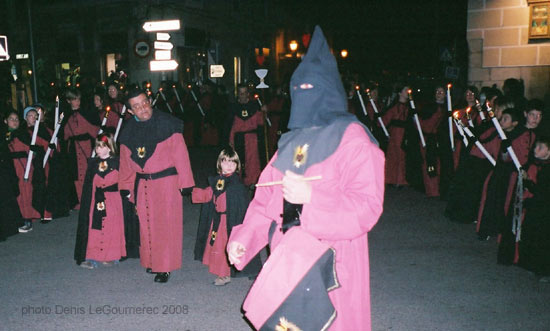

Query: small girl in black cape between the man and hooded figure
left=192, top=147, right=262, bottom=286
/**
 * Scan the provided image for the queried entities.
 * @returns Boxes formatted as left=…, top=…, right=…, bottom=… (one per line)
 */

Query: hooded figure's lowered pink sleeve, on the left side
left=228, top=158, right=282, bottom=270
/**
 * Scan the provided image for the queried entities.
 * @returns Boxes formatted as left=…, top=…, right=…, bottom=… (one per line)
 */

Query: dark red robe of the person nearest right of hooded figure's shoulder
left=382, top=103, right=409, bottom=185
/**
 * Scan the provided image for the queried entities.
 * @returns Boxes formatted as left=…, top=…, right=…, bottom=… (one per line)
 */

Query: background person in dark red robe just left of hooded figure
left=229, top=85, right=266, bottom=186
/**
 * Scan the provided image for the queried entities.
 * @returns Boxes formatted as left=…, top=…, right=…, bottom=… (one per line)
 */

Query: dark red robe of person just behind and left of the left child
left=64, top=111, right=99, bottom=209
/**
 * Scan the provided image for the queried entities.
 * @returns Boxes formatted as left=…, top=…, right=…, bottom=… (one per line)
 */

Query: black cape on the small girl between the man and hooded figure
left=195, top=173, right=262, bottom=277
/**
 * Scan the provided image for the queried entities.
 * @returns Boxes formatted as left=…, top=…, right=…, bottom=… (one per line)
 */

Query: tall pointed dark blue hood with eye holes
left=288, top=26, right=350, bottom=129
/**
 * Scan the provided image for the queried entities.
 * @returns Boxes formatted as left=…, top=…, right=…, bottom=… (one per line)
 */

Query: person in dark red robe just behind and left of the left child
left=63, top=90, right=100, bottom=209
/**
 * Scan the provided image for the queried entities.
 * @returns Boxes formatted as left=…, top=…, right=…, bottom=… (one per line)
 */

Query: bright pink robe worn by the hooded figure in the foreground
left=229, top=124, right=384, bottom=331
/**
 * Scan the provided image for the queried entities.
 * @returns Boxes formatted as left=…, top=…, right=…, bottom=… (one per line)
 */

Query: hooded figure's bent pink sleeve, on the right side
left=301, top=126, right=384, bottom=240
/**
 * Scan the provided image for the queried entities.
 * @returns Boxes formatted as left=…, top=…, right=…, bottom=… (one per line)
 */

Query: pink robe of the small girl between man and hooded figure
left=191, top=187, right=231, bottom=277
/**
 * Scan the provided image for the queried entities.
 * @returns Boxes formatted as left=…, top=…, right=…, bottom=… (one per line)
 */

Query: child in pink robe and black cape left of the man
left=74, top=133, right=126, bottom=269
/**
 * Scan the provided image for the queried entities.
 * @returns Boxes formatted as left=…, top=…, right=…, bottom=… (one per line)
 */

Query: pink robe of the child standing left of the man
left=86, top=170, right=126, bottom=262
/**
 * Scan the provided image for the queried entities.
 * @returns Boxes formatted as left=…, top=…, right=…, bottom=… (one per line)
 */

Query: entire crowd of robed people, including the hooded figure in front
left=0, top=37, right=550, bottom=327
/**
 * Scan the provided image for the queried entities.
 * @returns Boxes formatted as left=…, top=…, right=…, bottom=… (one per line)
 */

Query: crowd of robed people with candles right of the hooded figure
left=348, top=78, right=550, bottom=282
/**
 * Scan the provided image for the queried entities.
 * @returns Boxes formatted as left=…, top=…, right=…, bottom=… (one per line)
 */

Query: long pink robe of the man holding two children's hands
left=119, top=133, right=195, bottom=272
